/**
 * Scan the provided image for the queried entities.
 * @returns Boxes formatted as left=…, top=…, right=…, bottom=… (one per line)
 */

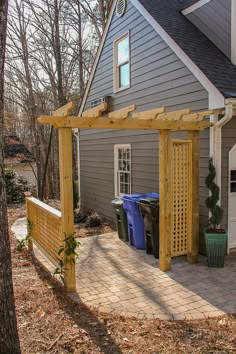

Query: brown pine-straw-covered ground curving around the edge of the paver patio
left=8, top=206, right=236, bottom=354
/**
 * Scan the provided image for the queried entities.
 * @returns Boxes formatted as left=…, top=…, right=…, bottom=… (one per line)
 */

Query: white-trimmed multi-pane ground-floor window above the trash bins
left=114, top=144, right=131, bottom=197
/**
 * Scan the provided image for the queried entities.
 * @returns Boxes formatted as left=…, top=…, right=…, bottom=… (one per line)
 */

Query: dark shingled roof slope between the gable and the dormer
left=139, top=0, right=236, bottom=98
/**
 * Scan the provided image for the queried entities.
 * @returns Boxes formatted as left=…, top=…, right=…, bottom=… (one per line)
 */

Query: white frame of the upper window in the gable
left=113, top=31, right=131, bottom=93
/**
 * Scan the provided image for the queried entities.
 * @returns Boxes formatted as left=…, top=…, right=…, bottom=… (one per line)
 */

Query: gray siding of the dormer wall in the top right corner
left=186, top=0, right=231, bottom=58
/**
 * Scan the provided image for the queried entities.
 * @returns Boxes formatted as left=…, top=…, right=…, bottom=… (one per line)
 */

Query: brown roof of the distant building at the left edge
left=4, top=135, right=34, bottom=163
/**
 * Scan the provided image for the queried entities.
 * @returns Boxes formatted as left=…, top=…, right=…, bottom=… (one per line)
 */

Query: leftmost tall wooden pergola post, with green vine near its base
left=58, top=128, right=76, bottom=292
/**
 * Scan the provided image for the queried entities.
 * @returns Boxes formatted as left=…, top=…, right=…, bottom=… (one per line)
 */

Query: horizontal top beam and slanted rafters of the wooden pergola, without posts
left=38, top=103, right=214, bottom=131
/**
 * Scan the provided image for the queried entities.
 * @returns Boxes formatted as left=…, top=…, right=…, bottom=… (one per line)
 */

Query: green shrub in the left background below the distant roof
left=4, top=169, right=31, bottom=203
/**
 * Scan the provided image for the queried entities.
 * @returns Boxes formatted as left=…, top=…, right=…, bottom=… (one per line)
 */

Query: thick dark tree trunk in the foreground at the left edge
left=0, top=0, right=21, bottom=354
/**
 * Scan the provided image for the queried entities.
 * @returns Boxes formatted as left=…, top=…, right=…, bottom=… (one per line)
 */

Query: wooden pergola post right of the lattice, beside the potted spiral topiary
left=187, top=130, right=200, bottom=263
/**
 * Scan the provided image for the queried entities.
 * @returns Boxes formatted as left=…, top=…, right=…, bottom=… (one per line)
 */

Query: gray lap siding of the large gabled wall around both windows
left=80, top=3, right=209, bottom=239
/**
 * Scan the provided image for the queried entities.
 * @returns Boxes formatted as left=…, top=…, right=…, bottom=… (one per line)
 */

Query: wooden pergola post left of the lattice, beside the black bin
left=159, top=130, right=171, bottom=272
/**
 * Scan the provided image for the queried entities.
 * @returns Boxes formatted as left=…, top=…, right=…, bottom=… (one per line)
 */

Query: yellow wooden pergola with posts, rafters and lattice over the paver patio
left=38, top=103, right=215, bottom=291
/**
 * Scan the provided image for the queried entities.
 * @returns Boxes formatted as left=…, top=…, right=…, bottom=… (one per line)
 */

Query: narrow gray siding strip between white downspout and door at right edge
left=221, top=117, right=236, bottom=226
